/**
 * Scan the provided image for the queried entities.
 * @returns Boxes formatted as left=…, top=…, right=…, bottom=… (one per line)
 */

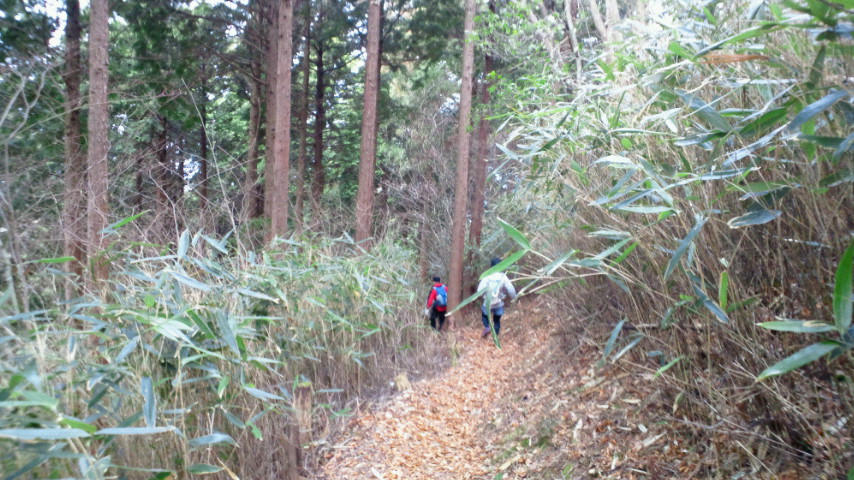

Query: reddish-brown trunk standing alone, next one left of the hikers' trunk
left=356, top=0, right=382, bottom=250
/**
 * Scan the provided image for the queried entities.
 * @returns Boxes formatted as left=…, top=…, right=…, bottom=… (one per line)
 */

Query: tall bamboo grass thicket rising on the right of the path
left=474, top=3, right=854, bottom=475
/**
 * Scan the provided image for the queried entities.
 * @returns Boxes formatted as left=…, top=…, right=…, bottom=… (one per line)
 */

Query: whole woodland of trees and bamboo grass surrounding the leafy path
left=0, top=0, right=854, bottom=479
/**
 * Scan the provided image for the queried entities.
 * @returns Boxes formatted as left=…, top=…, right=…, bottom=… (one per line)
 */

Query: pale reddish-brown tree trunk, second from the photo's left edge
left=86, top=0, right=110, bottom=288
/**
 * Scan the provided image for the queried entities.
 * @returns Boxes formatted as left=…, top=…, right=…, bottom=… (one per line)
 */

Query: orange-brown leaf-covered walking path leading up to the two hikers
left=323, top=308, right=560, bottom=480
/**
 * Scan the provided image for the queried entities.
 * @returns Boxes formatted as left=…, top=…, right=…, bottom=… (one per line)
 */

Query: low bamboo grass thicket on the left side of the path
left=0, top=232, right=434, bottom=478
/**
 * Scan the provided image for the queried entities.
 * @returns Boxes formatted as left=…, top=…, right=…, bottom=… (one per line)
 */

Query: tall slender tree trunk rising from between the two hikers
left=448, top=0, right=475, bottom=322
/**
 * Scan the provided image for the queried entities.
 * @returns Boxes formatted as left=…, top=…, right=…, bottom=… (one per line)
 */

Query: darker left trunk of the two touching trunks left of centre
left=264, top=0, right=279, bottom=218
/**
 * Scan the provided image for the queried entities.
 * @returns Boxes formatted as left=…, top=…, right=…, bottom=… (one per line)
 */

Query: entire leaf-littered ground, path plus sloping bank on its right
left=310, top=301, right=720, bottom=480
